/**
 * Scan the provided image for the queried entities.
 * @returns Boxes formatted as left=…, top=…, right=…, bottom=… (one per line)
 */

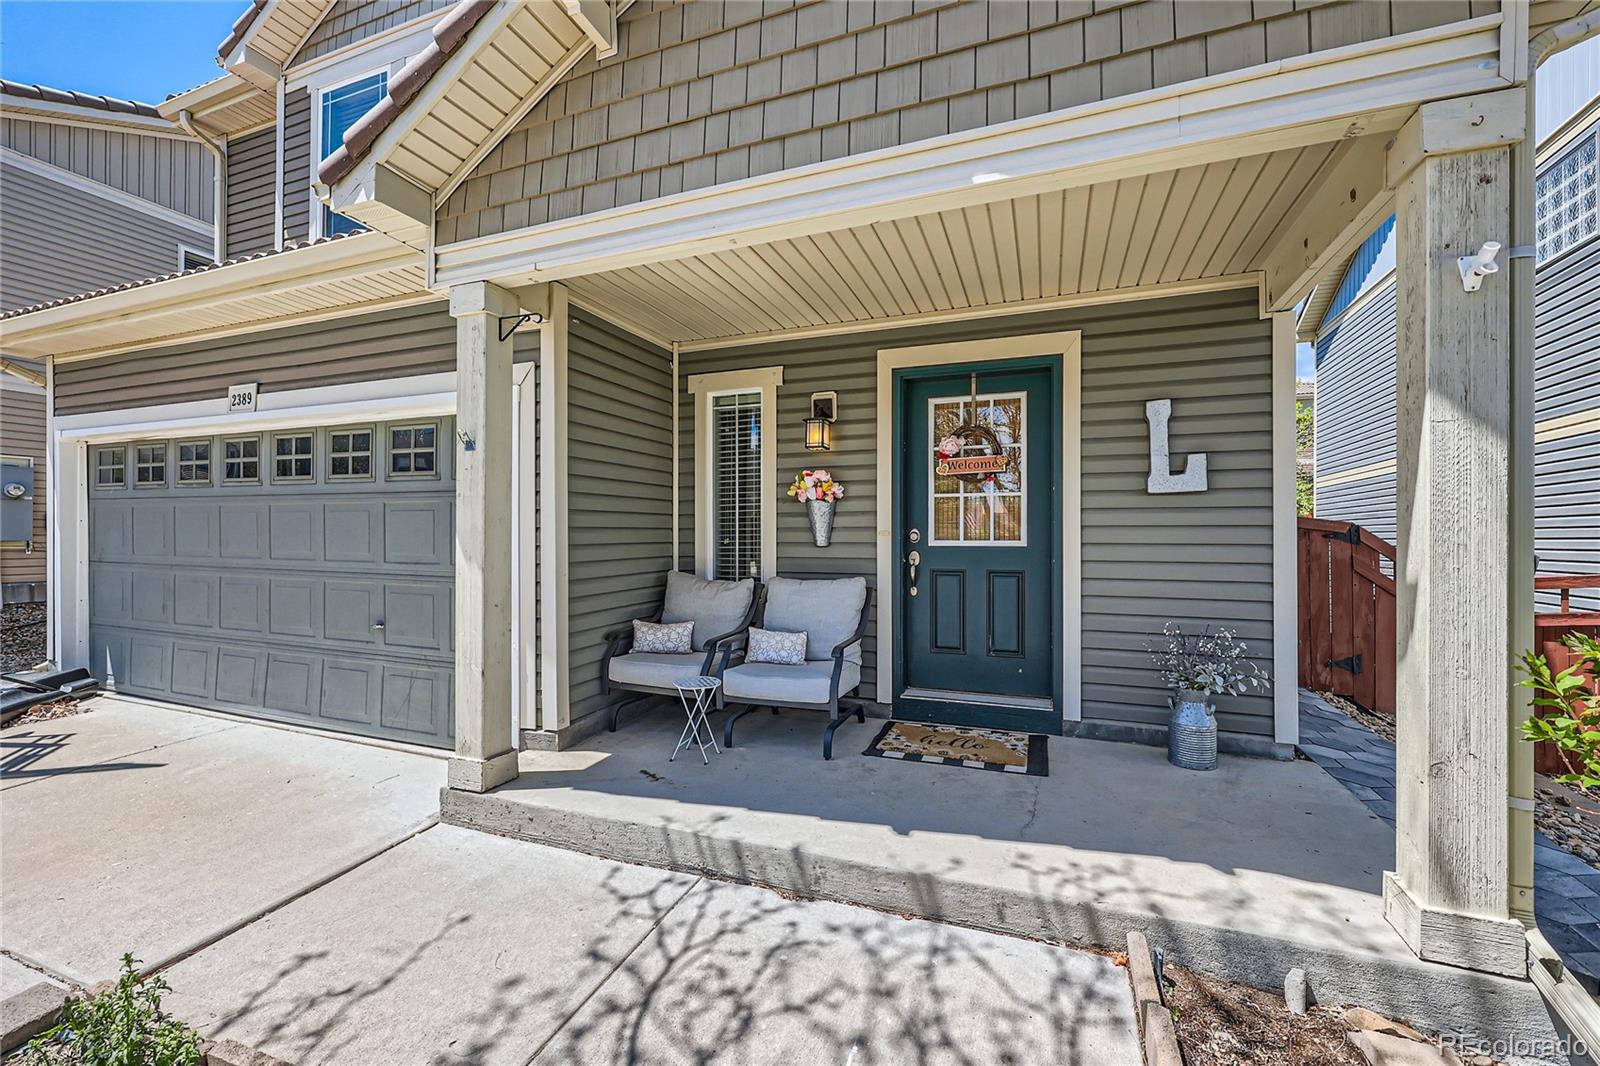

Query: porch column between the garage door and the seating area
left=448, top=282, right=517, bottom=792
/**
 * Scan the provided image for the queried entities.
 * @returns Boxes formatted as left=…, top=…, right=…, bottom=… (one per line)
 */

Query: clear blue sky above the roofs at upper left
left=0, top=0, right=236, bottom=104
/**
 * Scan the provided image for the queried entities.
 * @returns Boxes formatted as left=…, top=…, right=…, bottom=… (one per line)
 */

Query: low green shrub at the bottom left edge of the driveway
left=22, top=956, right=202, bottom=1066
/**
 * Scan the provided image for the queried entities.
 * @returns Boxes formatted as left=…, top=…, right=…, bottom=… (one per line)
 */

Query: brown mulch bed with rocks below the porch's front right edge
left=1163, top=965, right=1366, bottom=1066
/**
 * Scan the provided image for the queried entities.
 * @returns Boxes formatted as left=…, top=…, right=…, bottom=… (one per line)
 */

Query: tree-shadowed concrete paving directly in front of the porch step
left=165, top=826, right=1139, bottom=1066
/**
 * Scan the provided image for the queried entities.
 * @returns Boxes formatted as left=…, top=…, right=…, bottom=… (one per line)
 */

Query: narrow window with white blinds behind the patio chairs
left=710, top=391, right=762, bottom=581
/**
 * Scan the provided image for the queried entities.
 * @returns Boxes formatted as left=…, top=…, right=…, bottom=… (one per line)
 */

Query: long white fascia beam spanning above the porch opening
left=437, top=14, right=1504, bottom=285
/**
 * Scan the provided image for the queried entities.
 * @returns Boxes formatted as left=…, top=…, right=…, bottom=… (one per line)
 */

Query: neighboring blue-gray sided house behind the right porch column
left=1299, top=85, right=1600, bottom=607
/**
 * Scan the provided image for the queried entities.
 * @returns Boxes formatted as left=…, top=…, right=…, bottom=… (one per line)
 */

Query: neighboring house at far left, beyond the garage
left=0, top=80, right=214, bottom=603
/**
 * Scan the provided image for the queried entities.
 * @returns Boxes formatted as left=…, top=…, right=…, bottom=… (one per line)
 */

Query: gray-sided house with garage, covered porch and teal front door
left=0, top=0, right=1600, bottom=998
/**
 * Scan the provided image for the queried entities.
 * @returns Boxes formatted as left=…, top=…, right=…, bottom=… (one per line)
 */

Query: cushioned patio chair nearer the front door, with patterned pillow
left=717, top=578, right=872, bottom=759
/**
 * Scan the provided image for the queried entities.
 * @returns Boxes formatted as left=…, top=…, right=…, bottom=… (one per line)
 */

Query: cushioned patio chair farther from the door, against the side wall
left=600, top=570, right=763, bottom=733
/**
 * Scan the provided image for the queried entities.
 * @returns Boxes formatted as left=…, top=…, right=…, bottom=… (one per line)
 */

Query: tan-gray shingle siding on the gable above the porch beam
left=438, top=0, right=1496, bottom=243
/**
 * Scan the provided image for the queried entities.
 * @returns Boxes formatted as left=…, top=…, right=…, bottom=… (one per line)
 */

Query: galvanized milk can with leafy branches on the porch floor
left=1150, top=623, right=1269, bottom=770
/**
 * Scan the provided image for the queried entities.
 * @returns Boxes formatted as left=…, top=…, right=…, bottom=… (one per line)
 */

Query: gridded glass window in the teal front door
left=928, top=392, right=1027, bottom=544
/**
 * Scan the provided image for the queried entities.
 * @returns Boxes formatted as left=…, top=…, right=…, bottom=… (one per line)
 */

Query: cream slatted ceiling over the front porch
left=566, top=141, right=1360, bottom=344
